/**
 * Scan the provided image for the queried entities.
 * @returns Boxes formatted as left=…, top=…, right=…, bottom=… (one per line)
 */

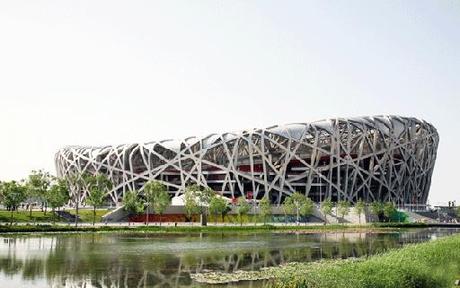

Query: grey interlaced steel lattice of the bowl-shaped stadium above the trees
left=55, top=116, right=439, bottom=206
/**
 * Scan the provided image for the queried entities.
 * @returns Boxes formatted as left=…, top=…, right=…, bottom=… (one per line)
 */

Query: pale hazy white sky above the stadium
left=0, top=0, right=460, bottom=204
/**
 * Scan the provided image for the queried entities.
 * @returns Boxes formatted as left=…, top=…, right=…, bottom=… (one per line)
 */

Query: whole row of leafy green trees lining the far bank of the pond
left=0, top=171, right=402, bottom=225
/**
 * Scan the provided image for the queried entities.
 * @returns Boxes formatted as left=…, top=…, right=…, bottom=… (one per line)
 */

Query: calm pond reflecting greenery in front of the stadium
left=0, top=228, right=460, bottom=288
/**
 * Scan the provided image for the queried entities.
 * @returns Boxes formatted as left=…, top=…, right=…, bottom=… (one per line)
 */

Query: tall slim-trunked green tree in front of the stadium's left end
left=84, top=174, right=113, bottom=226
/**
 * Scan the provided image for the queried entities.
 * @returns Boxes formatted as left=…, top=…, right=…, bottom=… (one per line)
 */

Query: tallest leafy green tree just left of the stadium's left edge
left=26, top=170, right=51, bottom=217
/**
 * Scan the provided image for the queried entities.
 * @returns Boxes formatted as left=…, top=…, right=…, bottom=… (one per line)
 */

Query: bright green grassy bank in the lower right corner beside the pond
left=271, top=235, right=460, bottom=288
